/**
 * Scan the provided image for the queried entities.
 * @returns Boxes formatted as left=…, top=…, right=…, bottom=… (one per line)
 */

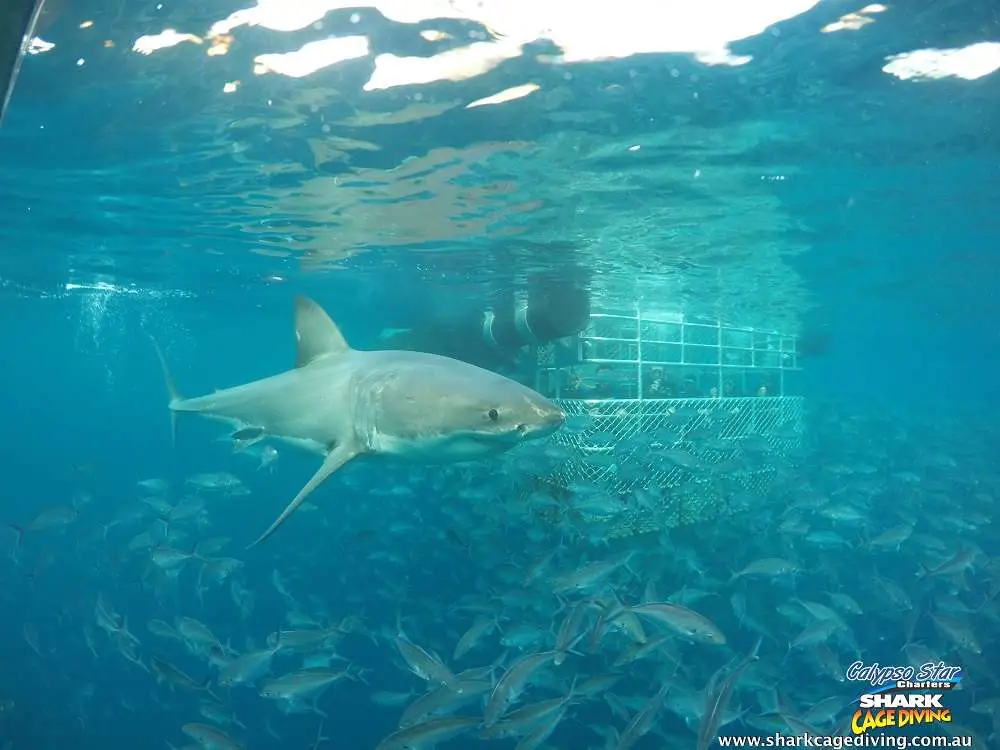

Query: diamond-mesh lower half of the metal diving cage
left=532, top=397, right=804, bottom=538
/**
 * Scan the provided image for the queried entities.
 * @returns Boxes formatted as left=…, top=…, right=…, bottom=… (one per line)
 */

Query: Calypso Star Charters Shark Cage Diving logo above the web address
left=846, top=661, right=962, bottom=735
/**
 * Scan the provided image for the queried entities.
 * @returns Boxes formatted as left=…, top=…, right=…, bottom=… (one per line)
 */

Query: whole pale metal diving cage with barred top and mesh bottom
left=532, top=311, right=803, bottom=538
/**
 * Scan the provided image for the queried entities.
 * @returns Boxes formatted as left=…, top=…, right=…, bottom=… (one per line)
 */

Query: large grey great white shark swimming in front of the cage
left=154, top=296, right=566, bottom=547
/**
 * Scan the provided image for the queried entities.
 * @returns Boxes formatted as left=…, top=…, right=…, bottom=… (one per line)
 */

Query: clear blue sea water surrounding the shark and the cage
left=0, top=0, right=1000, bottom=750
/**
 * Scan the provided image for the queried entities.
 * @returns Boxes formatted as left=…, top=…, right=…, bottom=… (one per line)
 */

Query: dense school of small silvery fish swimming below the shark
left=0, top=404, right=1000, bottom=750
